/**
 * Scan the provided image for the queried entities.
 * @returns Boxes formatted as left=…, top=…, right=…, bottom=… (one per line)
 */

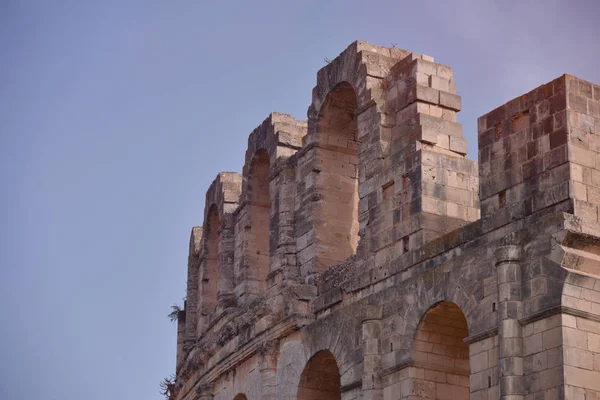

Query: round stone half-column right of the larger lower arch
left=496, top=245, right=524, bottom=400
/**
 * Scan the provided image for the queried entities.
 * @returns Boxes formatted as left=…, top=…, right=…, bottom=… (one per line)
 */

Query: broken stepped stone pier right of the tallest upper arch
left=376, top=54, right=479, bottom=267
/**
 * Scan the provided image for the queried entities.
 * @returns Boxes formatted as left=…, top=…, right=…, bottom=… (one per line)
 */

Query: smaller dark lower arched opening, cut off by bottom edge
left=298, top=350, right=342, bottom=400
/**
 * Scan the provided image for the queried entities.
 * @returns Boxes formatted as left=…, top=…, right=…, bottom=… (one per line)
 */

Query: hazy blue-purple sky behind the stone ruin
left=0, top=0, right=600, bottom=400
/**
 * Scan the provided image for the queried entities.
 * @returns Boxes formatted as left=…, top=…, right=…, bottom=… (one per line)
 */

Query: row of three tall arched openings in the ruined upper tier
left=200, top=82, right=359, bottom=312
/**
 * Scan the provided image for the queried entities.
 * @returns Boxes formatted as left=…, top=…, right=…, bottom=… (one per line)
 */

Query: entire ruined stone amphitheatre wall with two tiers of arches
left=173, top=41, right=600, bottom=400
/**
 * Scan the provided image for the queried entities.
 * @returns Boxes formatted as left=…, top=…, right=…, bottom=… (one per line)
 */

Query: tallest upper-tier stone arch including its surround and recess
left=295, top=41, right=409, bottom=280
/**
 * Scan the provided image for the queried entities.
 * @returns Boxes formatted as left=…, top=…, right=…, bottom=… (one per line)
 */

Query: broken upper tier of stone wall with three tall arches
left=177, top=41, right=477, bottom=384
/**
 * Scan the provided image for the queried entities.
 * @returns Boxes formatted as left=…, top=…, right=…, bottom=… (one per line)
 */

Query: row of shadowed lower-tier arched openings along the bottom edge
left=224, top=301, right=470, bottom=400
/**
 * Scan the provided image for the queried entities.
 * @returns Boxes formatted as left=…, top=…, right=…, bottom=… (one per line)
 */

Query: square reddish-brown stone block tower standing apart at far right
left=478, top=75, right=600, bottom=238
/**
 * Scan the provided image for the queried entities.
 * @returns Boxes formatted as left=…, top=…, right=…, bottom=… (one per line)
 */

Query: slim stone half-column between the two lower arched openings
left=362, top=306, right=383, bottom=400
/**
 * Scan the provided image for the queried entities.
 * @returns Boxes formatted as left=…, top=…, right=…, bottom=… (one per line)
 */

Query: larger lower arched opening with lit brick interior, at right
left=410, top=301, right=470, bottom=400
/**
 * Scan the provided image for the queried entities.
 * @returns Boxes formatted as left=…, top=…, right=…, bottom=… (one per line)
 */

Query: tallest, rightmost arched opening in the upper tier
left=315, top=82, right=358, bottom=272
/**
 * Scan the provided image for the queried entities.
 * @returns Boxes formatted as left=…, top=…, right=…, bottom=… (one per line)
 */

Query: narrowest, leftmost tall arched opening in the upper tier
left=200, top=204, right=221, bottom=315
